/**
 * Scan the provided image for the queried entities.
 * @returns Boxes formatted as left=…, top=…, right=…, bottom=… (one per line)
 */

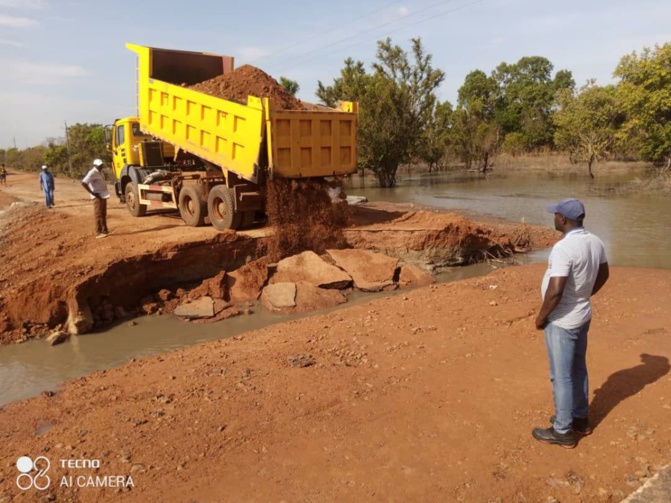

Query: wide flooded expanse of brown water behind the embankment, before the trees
left=347, top=171, right=671, bottom=269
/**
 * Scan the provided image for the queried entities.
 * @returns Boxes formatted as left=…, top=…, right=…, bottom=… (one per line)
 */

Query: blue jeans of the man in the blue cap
left=545, top=321, right=590, bottom=433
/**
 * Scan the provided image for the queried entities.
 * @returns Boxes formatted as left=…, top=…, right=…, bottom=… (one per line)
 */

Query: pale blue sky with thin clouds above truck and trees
left=0, top=0, right=671, bottom=148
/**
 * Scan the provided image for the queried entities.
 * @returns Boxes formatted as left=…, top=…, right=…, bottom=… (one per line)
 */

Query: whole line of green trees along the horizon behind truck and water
left=0, top=38, right=671, bottom=187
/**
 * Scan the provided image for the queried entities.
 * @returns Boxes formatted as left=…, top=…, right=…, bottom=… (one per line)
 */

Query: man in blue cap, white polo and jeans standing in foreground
left=532, top=199, right=609, bottom=449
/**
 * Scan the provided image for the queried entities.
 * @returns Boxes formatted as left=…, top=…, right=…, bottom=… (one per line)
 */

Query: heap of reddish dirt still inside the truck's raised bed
left=190, top=65, right=305, bottom=110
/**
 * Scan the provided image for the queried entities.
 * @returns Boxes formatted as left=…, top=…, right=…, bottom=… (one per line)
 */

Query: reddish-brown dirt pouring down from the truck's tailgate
left=266, top=179, right=351, bottom=261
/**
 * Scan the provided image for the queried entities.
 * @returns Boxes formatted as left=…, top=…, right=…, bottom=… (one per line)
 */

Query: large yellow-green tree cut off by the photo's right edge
left=613, top=43, right=671, bottom=171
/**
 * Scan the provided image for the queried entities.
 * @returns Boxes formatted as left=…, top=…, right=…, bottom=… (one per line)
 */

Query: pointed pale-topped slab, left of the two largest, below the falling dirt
left=270, top=251, right=352, bottom=289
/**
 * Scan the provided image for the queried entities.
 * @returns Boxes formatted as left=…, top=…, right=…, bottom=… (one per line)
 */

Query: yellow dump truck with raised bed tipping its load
left=110, top=44, right=358, bottom=230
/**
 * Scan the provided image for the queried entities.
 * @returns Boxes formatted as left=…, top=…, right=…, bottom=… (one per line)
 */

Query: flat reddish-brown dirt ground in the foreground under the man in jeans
left=0, top=264, right=671, bottom=503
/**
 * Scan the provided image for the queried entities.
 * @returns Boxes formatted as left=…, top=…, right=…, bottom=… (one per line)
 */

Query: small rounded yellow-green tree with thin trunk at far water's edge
left=554, top=81, right=622, bottom=178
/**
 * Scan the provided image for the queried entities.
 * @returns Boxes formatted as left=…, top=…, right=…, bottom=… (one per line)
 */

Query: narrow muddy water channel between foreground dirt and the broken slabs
left=0, top=264, right=492, bottom=406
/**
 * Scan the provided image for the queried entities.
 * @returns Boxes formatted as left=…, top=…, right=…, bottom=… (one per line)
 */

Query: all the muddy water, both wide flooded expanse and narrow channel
left=0, top=174, right=671, bottom=405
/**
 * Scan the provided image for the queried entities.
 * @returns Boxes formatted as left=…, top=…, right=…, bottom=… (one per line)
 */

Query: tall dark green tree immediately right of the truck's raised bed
left=317, top=38, right=445, bottom=187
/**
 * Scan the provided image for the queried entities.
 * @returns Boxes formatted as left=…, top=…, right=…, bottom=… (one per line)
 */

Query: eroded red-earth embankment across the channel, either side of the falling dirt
left=0, top=203, right=554, bottom=343
